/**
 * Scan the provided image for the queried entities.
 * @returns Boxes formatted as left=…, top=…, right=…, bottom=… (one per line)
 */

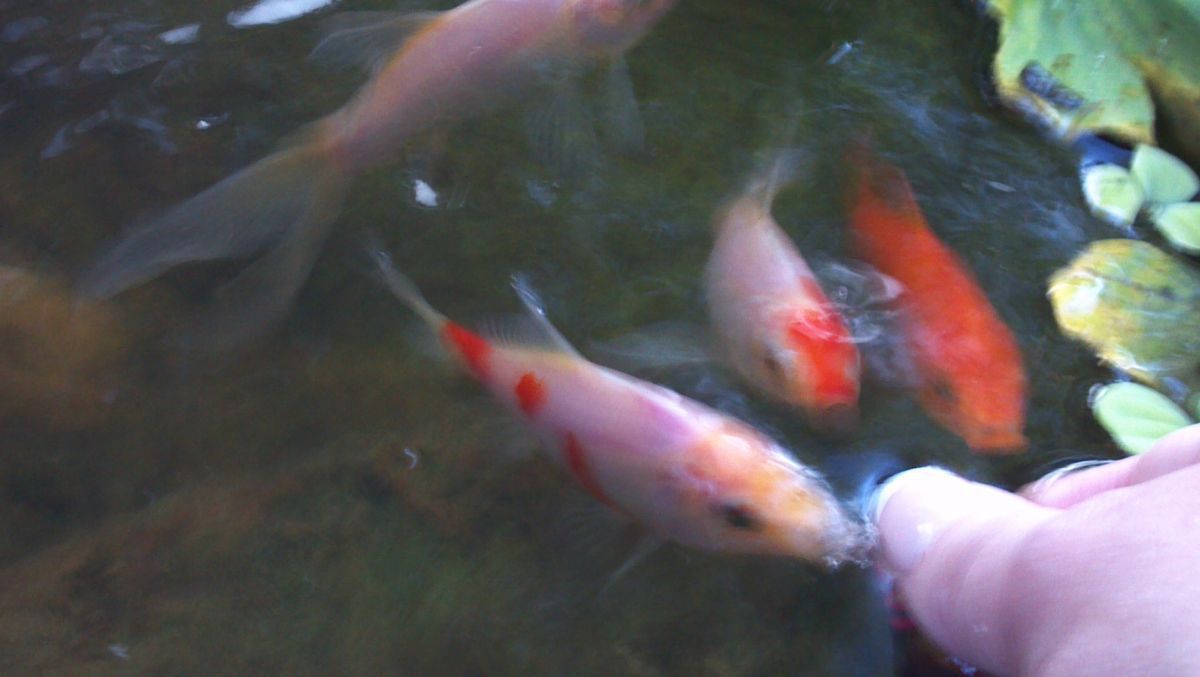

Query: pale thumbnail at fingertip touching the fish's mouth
left=869, top=466, right=972, bottom=576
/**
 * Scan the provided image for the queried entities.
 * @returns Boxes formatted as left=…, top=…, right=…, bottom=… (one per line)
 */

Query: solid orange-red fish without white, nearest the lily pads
left=850, top=144, right=1026, bottom=454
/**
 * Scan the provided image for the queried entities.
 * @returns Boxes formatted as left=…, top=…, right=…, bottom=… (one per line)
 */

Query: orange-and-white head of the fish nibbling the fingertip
left=667, top=423, right=862, bottom=561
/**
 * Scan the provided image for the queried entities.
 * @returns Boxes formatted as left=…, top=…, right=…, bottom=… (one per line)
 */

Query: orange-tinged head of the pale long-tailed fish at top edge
left=570, top=0, right=676, bottom=55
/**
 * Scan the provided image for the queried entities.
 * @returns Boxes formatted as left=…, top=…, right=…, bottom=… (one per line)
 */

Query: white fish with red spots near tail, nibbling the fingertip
left=373, top=246, right=863, bottom=565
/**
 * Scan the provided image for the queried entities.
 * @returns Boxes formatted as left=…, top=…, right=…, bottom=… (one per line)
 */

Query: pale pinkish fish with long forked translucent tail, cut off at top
left=79, top=0, right=674, bottom=346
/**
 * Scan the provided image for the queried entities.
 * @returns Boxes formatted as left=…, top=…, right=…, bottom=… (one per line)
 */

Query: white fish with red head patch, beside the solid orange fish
left=704, top=154, right=859, bottom=432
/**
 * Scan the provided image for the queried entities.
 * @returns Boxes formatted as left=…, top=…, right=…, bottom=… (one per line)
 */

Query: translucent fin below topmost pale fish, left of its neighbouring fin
left=526, top=76, right=600, bottom=179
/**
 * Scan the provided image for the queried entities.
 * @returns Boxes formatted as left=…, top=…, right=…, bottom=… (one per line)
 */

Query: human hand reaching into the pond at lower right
left=874, top=425, right=1200, bottom=675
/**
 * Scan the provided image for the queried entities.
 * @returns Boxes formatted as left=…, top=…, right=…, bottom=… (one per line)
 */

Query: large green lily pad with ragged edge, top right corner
left=984, top=0, right=1200, bottom=157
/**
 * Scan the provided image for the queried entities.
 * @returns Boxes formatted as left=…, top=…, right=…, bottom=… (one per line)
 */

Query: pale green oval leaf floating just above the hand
left=1092, top=383, right=1192, bottom=454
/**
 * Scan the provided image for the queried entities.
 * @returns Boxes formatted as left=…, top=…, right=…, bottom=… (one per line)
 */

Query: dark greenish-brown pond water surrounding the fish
left=0, top=0, right=1115, bottom=675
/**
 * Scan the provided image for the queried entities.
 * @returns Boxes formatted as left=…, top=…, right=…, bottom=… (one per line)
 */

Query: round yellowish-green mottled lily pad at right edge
left=1049, top=240, right=1200, bottom=385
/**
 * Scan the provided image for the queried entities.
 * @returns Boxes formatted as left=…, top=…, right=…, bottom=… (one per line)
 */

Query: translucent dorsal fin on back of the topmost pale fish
left=308, top=12, right=445, bottom=72
